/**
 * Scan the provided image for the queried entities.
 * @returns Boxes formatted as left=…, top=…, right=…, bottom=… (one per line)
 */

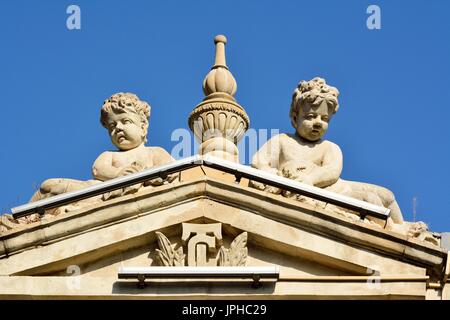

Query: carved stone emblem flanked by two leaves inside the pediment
left=155, top=223, right=248, bottom=267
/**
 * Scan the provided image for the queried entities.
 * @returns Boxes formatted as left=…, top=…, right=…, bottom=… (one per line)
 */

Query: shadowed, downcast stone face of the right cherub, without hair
left=295, top=100, right=333, bottom=141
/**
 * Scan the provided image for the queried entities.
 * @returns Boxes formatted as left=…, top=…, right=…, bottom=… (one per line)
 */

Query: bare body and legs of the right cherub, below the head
left=252, top=134, right=403, bottom=222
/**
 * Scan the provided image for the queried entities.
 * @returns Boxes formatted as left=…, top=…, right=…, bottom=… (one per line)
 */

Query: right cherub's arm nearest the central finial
left=252, top=134, right=283, bottom=174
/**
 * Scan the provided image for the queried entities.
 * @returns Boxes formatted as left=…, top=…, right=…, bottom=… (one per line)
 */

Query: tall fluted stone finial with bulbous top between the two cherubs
left=188, top=35, right=250, bottom=162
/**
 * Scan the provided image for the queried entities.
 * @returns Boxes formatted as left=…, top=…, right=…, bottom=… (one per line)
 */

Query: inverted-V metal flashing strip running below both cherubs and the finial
left=11, top=155, right=390, bottom=220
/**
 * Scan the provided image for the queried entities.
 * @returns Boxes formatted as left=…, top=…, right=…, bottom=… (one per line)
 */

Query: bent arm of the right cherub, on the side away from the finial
left=304, top=141, right=343, bottom=188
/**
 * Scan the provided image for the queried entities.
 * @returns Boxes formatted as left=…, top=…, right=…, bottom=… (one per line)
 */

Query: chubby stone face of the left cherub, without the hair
left=108, top=113, right=146, bottom=150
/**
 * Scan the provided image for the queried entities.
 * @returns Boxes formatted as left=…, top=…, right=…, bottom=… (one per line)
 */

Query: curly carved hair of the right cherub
left=289, top=77, right=339, bottom=128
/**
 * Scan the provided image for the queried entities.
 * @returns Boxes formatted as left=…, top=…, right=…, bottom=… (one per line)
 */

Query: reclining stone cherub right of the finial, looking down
left=250, top=78, right=438, bottom=242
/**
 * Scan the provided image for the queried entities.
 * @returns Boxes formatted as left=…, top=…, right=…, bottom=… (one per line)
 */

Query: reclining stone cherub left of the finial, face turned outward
left=0, top=93, right=177, bottom=229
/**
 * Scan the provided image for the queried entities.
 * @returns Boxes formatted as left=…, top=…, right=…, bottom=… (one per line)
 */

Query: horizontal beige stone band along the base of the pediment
left=0, top=276, right=426, bottom=299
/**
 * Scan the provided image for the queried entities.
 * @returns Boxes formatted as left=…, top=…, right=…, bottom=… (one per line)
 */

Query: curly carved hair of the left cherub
left=100, top=92, right=151, bottom=142
